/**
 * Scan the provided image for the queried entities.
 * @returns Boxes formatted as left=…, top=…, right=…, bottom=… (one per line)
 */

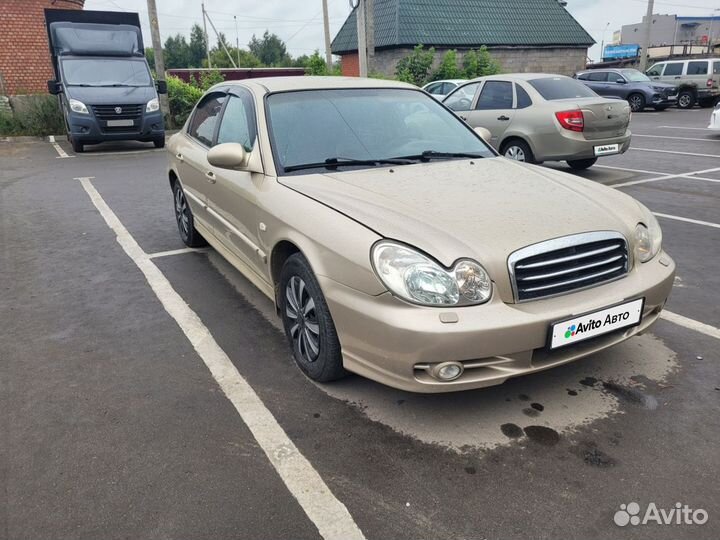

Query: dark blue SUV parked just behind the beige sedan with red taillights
left=575, top=69, right=678, bottom=112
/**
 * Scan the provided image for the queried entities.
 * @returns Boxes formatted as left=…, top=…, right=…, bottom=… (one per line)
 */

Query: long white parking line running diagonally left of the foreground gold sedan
left=79, top=178, right=365, bottom=540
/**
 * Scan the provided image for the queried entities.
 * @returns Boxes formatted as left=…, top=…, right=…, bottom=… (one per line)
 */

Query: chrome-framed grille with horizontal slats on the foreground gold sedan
left=508, top=231, right=629, bottom=302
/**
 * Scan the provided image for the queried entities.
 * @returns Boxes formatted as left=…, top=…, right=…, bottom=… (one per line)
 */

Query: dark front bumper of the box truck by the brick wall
left=67, top=111, right=165, bottom=144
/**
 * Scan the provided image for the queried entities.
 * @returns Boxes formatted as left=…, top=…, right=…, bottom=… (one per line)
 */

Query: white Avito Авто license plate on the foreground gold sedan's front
left=550, top=298, right=645, bottom=349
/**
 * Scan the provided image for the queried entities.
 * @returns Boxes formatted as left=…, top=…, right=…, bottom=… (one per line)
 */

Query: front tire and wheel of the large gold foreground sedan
left=278, top=253, right=347, bottom=382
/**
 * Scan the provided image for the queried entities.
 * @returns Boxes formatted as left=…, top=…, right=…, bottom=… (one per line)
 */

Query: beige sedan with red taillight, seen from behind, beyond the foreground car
left=443, top=73, right=630, bottom=169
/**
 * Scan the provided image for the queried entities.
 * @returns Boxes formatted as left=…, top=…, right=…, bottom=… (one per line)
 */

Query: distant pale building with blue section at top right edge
left=620, top=14, right=720, bottom=50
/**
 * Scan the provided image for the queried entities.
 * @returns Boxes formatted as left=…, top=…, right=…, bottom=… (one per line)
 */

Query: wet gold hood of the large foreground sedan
left=279, top=157, right=642, bottom=300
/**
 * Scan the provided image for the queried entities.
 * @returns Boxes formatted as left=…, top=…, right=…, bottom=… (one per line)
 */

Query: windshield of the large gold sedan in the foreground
left=267, top=88, right=495, bottom=172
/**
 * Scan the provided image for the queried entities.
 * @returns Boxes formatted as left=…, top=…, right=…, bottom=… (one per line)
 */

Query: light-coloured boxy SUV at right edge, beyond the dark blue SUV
left=645, top=58, right=720, bottom=109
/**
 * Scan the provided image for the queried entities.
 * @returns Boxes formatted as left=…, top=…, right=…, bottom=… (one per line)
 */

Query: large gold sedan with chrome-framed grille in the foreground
left=165, top=77, right=675, bottom=392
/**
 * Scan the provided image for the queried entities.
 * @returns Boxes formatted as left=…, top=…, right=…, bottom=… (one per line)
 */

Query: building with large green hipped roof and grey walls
left=332, top=0, right=595, bottom=76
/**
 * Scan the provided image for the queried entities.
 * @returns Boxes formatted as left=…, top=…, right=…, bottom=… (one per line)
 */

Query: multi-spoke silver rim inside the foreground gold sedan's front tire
left=285, top=276, right=320, bottom=363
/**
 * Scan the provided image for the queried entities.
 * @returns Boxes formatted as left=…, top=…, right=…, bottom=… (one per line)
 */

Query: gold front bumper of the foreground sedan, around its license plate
left=318, top=252, right=675, bottom=393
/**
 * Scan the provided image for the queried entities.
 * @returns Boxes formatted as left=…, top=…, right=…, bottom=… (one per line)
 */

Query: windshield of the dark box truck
left=62, top=58, right=152, bottom=86
